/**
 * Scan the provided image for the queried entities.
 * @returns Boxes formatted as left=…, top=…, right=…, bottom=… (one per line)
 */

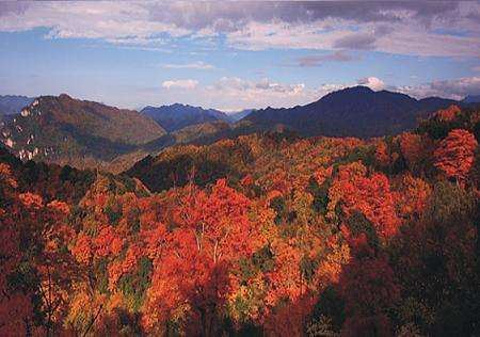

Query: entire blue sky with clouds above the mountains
left=0, top=1, right=480, bottom=112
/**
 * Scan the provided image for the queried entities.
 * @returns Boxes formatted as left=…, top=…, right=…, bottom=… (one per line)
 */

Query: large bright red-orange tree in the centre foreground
left=144, top=180, right=263, bottom=336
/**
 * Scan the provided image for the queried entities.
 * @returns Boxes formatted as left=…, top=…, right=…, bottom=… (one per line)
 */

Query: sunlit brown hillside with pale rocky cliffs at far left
left=0, top=94, right=165, bottom=167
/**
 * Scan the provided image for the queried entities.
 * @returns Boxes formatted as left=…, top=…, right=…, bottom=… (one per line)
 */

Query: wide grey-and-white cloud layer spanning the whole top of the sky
left=0, top=1, right=480, bottom=57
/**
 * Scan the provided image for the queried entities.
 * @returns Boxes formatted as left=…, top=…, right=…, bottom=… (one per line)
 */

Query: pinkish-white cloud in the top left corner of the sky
left=0, top=1, right=189, bottom=45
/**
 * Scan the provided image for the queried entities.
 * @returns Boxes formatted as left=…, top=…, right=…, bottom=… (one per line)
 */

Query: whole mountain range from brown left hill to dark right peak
left=0, top=86, right=474, bottom=172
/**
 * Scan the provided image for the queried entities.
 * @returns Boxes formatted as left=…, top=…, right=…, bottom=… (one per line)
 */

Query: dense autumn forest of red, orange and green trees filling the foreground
left=0, top=106, right=480, bottom=337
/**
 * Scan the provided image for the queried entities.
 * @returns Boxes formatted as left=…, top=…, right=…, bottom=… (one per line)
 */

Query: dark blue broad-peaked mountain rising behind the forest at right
left=244, top=86, right=458, bottom=137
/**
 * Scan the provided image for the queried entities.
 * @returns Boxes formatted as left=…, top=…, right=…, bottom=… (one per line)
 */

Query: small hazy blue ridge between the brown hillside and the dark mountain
left=140, top=103, right=233, bottom=132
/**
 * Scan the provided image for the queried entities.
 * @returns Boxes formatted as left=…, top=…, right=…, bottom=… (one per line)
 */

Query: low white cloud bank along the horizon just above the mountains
left=123, top=76, right=480, bottom=111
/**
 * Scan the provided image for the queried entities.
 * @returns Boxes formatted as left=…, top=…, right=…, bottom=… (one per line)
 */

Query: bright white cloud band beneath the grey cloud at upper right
left=227, top=19, right=480, bottom=57
